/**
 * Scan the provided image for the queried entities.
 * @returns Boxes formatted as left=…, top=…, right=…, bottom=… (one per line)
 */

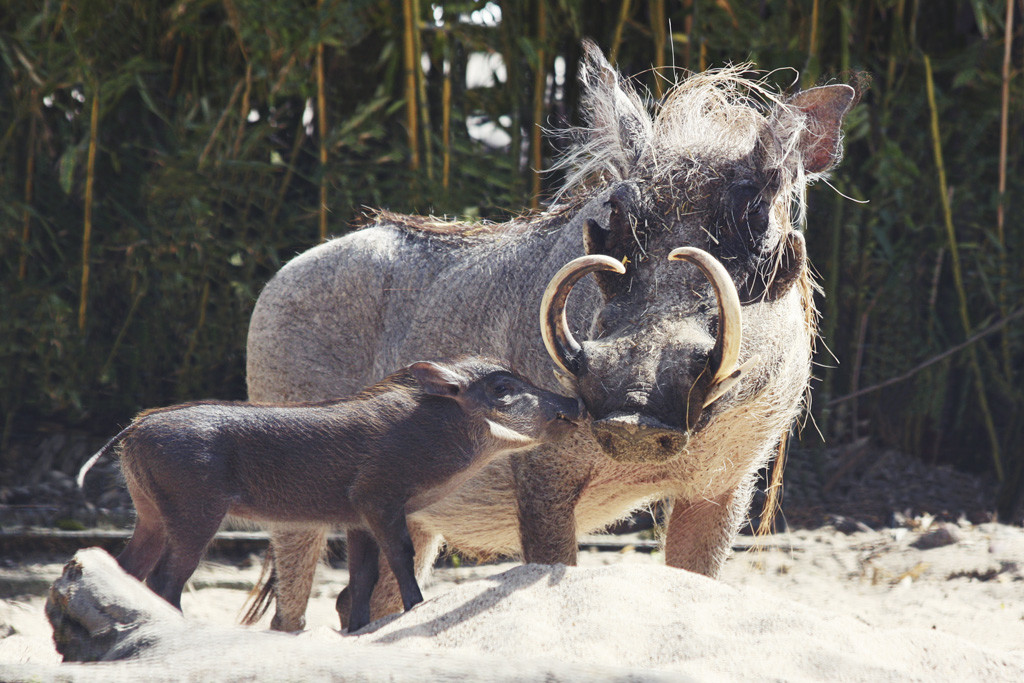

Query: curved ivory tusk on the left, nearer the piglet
left=541, top=254, right=626, bottom=376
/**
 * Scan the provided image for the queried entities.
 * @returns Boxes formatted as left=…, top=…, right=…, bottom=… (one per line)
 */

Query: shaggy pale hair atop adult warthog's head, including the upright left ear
left=550, top=41, right=816, bottom=229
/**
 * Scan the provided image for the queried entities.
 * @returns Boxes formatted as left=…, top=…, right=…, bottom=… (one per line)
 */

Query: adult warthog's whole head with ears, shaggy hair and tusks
left=541, top=45, right=855, bottom=461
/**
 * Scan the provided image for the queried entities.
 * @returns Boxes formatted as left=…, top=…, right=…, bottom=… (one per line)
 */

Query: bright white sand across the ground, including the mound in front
left=0, top=524, right=1024, bottom=681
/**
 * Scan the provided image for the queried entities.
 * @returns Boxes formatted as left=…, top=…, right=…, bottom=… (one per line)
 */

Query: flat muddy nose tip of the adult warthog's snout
left=591, top=413, right=689, bottom=462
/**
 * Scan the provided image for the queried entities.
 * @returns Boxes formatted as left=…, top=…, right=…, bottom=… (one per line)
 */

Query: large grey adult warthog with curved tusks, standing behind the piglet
left=241, top=44, right=855, bottom=630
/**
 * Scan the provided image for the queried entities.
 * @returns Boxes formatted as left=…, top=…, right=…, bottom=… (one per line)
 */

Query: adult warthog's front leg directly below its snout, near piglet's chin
left=512, top=446, right=591, bottom=565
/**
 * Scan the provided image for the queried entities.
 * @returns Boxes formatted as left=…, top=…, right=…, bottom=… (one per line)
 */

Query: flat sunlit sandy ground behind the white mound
left=0, top=518, right=1024, bottom=678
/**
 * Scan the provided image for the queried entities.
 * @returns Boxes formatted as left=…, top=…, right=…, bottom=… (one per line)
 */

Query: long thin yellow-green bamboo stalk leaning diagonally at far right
left=924, top=54, right=1004, bottom=481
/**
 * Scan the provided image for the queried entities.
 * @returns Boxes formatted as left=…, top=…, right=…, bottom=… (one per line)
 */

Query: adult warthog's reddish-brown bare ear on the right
left=788, top=84, right=857, bottom=173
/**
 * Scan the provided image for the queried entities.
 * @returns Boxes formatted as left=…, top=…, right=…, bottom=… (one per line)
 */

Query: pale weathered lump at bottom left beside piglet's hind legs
left=46, top=548, right=185, bottom=661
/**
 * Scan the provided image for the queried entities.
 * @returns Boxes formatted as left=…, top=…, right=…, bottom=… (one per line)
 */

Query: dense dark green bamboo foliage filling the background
left=0, top=0, right=1024, bottom=508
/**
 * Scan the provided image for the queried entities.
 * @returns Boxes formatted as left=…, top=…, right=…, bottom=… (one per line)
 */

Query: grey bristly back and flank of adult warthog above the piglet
left=247, top=215, right=583, bottom=401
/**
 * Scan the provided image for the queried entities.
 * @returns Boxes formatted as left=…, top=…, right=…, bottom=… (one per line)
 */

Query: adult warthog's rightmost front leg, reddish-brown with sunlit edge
left=665, top=472, right=757, bottom=579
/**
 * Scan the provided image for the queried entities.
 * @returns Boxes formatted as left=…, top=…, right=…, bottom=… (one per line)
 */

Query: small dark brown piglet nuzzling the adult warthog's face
left=79, top=358, right=581, bottom=631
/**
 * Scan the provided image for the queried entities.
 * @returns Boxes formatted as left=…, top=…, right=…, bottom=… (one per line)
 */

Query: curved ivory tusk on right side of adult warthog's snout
left=669, top=247, right=752, bottom=407
